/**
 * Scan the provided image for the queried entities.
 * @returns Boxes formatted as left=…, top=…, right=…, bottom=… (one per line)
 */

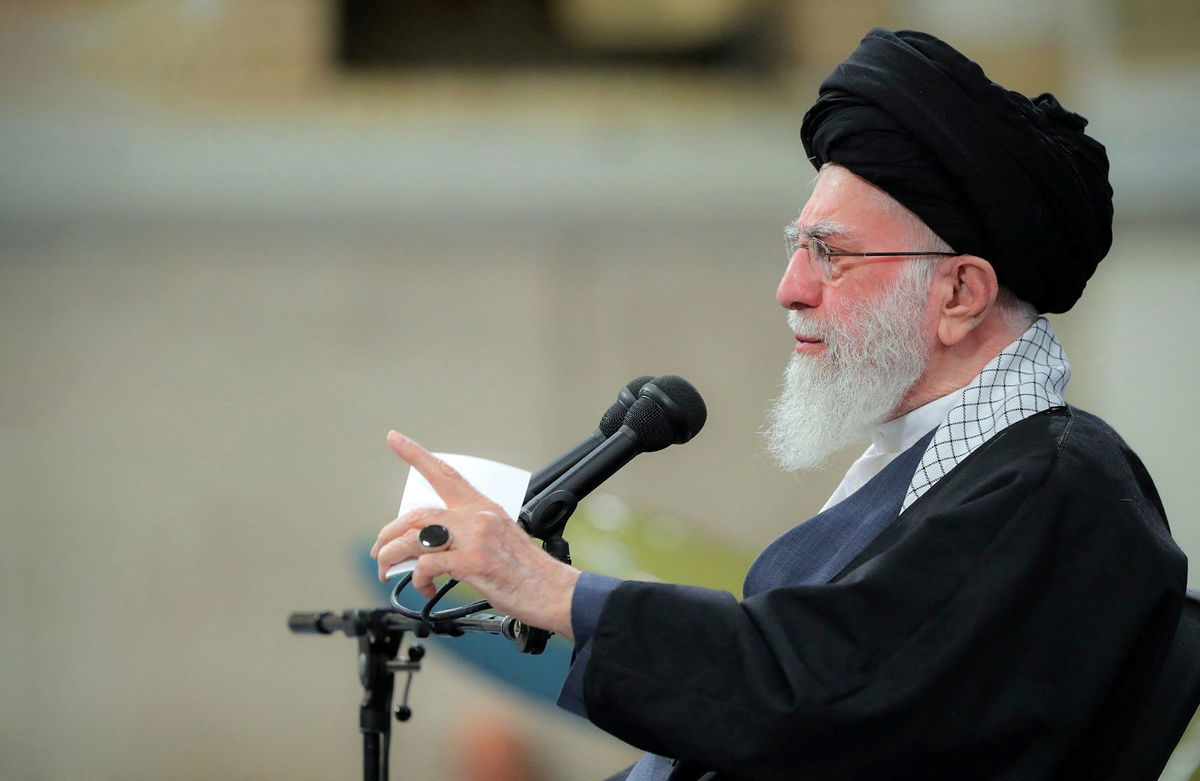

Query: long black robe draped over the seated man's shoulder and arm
left=583, top=407, right=1187, bottom=780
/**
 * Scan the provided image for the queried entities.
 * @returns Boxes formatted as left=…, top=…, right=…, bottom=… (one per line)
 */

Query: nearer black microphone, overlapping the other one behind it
left=517, top=374, right=708, bottom=540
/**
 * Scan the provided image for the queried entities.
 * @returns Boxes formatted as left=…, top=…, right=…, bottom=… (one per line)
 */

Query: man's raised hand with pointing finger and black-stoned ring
left=371, top=432, right=580, bottom=639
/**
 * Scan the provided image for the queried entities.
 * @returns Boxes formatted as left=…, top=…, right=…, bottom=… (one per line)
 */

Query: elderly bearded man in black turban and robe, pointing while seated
left=372, top=30, right=1186, bottom=779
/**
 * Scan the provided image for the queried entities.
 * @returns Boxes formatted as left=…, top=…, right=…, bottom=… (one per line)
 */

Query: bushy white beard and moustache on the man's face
left=763, top=274, right=929, bottom=471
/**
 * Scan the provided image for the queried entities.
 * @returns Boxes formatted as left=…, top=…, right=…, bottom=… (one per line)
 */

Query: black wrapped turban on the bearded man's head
left=800, top=29, right=1112, bottom=312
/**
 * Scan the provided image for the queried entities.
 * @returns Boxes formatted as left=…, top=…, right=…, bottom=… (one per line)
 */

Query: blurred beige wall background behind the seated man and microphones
left=0, top=0, right=1200, bottom=781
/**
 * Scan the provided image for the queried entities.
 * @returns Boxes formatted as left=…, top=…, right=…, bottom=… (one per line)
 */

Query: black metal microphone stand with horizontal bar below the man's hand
left=288, top=608, right=520, bottom=781
